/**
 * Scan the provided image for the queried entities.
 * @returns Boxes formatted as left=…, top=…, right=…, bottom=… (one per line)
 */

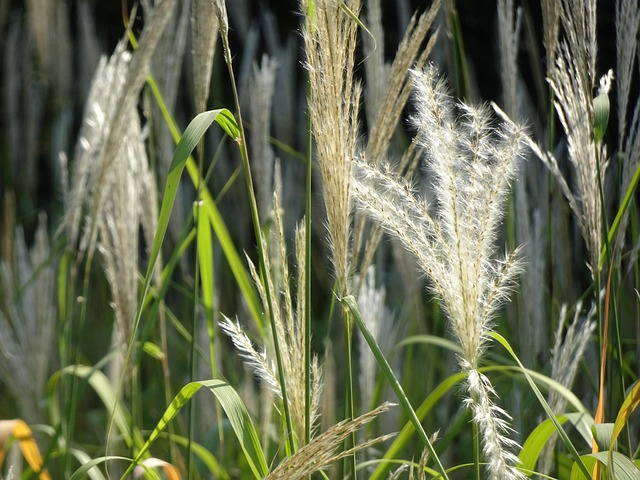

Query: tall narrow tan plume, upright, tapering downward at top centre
left=300, top=0, right=362, bottom=297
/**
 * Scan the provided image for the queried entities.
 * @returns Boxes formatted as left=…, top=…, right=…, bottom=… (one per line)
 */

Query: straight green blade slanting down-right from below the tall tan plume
left=342, top=295, right=449, bottom=480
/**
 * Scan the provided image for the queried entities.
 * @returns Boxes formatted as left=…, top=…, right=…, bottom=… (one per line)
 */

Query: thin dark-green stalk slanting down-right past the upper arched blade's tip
left=221, top=29, right=295, bottom=454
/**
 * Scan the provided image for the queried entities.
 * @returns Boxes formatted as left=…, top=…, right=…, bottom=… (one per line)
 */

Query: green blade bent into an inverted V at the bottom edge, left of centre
left=122, top=379, right=268, bottom=479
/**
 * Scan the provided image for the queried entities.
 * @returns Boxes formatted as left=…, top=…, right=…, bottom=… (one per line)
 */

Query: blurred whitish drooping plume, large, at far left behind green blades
left=64, top=38, right=159, bottom=390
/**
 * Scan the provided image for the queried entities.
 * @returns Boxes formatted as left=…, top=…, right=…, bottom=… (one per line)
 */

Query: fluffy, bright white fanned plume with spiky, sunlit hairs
left=353, top=67, right=523, bottom=480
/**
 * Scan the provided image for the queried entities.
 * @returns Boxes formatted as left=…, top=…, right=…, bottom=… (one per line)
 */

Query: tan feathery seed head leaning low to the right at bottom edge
left=265, top=403, right=393, bottom=480
